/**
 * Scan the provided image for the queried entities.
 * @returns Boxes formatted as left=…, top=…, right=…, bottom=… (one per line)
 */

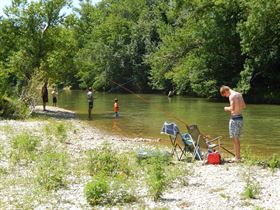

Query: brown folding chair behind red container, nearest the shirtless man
left=187, top=125, right=235, bottom=156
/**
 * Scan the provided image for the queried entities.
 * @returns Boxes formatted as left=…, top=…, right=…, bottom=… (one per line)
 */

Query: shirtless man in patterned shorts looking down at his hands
left=220, top=86, right=246, bottom=162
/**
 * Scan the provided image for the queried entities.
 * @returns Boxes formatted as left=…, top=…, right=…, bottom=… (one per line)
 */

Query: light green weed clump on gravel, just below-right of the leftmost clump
left=36, top=146, right=67, bottom=191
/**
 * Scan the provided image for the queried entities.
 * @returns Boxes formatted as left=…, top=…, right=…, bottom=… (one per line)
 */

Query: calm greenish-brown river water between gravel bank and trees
left=58, top=91, right=280, bottom=156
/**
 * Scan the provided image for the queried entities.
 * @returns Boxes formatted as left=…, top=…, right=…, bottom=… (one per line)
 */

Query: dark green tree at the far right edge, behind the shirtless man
left=238, top=0, right=280, bottom=102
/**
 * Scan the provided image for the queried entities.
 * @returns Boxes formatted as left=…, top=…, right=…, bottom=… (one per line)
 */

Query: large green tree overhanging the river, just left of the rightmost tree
left=149, top=0, right=244, bottom=97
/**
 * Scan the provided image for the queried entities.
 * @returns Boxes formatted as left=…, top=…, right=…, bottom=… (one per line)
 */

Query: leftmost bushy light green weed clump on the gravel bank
left=10, top=132, right=40, bottom=162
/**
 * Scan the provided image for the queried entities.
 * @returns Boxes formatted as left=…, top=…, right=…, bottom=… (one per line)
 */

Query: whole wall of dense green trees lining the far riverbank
left=0, top=0, right=280, bottom=110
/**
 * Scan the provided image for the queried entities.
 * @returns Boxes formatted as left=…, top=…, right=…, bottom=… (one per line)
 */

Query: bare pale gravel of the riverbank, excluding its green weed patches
left=0, top=106, right=280, bottom=210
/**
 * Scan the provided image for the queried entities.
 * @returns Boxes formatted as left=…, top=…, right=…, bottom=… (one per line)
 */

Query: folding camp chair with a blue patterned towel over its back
left=161, top=122, right=202, bottom=160
